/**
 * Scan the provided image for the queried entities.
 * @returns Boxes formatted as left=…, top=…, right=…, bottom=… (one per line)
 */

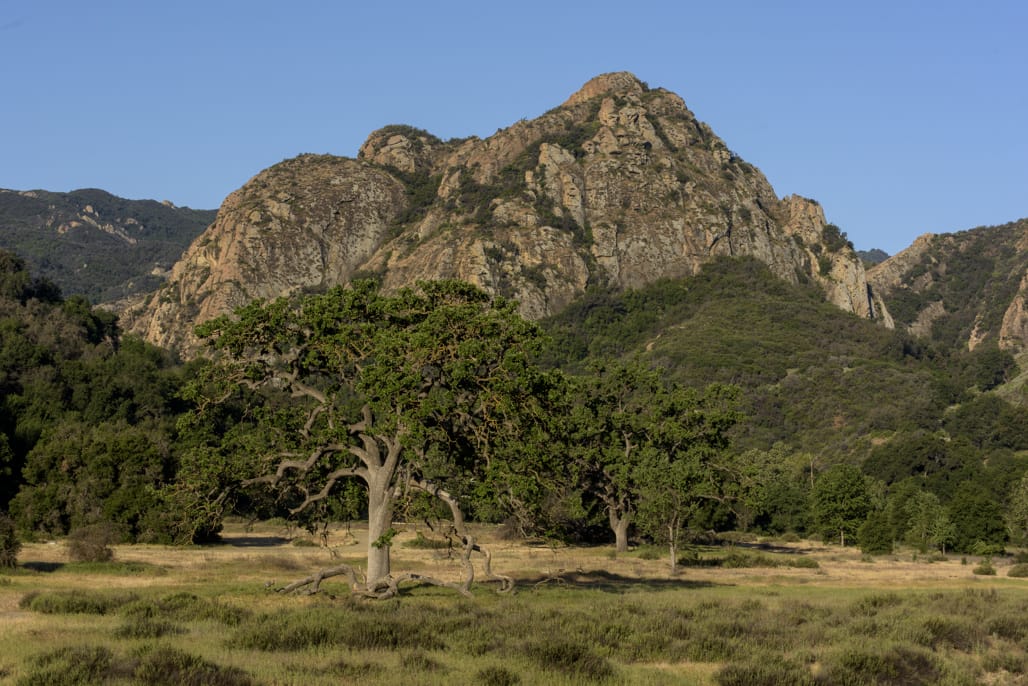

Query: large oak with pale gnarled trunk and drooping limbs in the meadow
left=182, top=281, right=551, bottom=594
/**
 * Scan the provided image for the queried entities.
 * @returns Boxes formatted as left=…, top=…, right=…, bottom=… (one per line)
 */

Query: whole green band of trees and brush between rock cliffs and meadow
left=0, top=252, right=1028, bottom=557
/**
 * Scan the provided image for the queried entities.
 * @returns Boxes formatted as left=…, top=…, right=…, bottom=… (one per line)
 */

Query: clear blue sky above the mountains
left=0, top=0, right=1028, bottom=253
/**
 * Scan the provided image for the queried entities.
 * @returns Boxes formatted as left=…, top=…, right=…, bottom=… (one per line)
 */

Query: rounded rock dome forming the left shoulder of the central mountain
left=122, top=155, right=404, bottom=350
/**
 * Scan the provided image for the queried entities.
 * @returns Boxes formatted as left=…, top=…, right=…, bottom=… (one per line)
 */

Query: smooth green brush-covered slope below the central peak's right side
left=546, top=258, right=1028, bottom=464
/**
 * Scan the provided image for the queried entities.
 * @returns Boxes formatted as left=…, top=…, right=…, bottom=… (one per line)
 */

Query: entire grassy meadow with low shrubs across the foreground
left=0, top=522, right=1028, bottom=686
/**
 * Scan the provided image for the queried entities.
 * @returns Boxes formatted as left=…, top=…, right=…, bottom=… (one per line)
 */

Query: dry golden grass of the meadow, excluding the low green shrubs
left=6, top=522, right=1028, bottom=684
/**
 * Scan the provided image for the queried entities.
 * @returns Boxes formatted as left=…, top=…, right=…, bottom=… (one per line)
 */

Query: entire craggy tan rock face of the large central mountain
left=124, top=72, right=891, bottom=349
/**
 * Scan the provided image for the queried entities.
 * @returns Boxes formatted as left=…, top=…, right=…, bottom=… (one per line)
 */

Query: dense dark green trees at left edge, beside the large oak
left=0, top=252, right=188, bottom=540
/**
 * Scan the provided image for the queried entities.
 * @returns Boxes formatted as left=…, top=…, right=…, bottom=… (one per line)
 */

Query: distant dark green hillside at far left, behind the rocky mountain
left=0, top=188, right=217, bottom=302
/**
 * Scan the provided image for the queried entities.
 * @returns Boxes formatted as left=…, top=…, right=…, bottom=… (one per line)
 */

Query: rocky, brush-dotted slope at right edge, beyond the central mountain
left=868, top=219, right=1028, bottom=352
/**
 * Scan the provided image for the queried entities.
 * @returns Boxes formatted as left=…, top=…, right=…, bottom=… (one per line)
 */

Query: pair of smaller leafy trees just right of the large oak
left=567, top=360, right=738, bottom=561
